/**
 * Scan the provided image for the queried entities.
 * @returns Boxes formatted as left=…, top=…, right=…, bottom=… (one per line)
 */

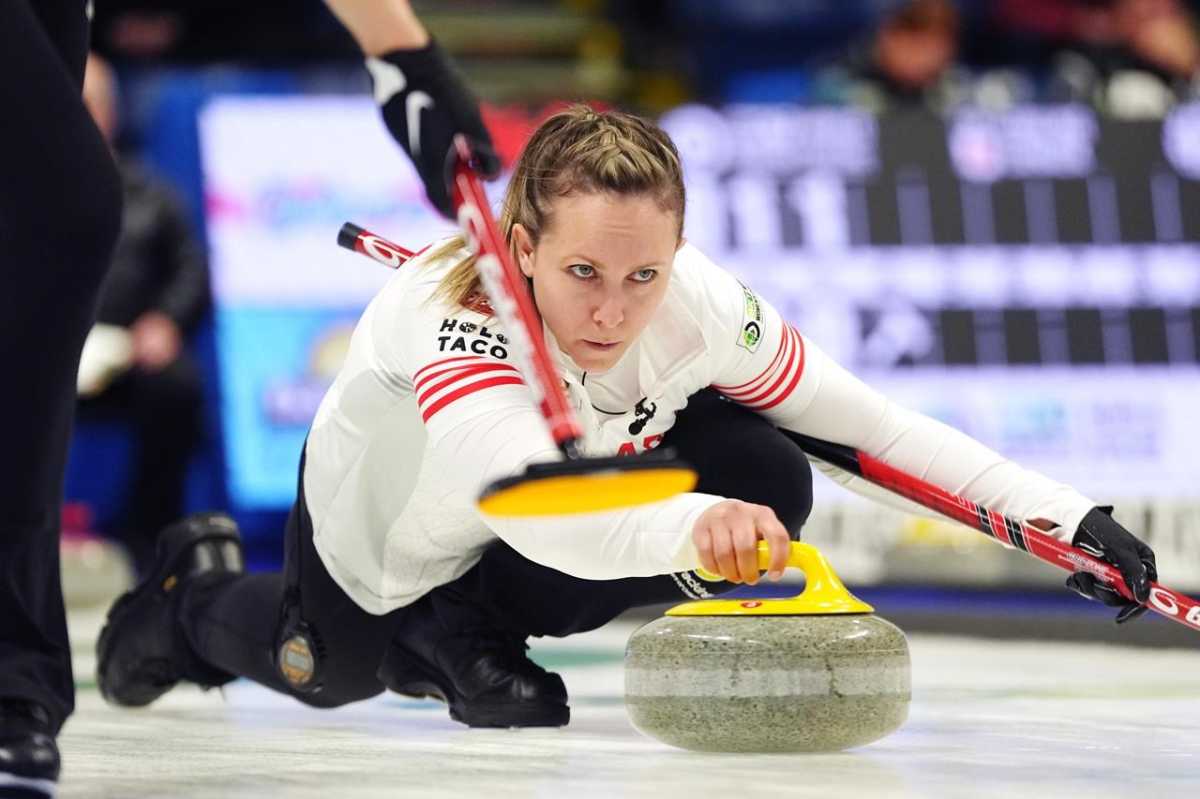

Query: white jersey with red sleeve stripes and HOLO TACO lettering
left=304, top=239, right=1096, bottom=613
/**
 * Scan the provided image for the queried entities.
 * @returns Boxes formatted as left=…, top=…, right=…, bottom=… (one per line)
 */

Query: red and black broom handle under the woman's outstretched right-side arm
left=791, top=433, right=1200, bottom=630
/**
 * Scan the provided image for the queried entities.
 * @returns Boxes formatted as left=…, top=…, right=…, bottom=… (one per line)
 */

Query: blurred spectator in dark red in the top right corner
left=991, top=0, right=1200, bottom=114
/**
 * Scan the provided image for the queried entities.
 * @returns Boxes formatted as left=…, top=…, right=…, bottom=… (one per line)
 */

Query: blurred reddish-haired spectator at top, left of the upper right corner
left=814, top=0, right=962, bottom=110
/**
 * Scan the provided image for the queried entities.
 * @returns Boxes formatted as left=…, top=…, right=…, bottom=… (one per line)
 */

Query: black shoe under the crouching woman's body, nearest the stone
left=379, top=590, right=571, bottom=727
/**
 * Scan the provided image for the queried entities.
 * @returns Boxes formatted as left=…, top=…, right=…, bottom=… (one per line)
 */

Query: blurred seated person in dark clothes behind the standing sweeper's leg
left=78, top=55, right=209, bottom=572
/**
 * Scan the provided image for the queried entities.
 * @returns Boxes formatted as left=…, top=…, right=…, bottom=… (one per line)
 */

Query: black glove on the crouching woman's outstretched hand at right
left=1067, top=507, right=1158, bottom=624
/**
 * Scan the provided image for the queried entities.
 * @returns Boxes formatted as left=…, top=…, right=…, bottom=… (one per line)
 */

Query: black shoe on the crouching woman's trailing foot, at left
left=96, top=513, right=244, bottom=707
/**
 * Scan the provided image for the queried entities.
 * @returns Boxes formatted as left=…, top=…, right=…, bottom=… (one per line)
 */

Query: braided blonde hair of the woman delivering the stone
left=427, top=106, right=685, bottom=306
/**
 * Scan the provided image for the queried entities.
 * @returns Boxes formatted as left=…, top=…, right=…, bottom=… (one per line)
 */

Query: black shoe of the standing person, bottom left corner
left=0, top=699, right=60, bottom=799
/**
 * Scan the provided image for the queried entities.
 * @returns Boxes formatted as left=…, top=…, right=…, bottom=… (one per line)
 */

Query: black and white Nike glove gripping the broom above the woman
left=367, top=40, right=500, bottom=218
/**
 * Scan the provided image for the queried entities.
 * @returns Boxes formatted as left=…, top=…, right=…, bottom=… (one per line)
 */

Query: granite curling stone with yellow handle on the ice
left=625, top=542, right=912, bottom=752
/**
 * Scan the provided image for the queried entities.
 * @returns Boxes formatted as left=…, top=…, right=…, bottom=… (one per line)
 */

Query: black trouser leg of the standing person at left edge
left=0, top=0, right=121, bottom=727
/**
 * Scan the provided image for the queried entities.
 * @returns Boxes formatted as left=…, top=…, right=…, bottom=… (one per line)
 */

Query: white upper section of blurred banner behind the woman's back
left=199, top=97, right=456, bottom=307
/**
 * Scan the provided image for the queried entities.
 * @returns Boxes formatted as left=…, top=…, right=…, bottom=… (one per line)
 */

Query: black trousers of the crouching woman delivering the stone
left=180, top=390, right=812, bottom=707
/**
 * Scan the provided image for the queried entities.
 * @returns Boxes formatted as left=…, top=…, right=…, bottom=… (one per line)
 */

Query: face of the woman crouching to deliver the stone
left=512, top=192, right=682, bottom=372
